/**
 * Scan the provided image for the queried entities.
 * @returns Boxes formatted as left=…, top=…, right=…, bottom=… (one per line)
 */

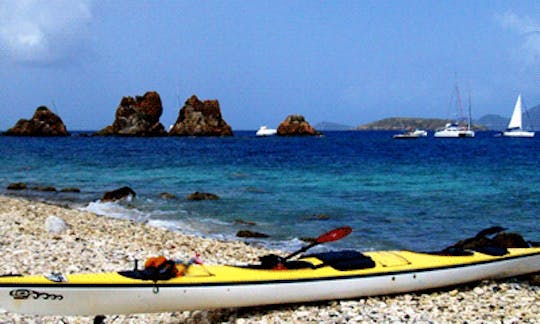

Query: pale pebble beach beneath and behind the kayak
left=0, top=196, right=540, bottom=323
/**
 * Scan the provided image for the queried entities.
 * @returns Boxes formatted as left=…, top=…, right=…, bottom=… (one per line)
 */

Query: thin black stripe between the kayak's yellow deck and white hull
left=0, top=252, right=540, bottom=288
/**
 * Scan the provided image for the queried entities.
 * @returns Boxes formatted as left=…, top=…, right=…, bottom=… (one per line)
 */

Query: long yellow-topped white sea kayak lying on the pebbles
left=0, top=248, right=540, bottom=315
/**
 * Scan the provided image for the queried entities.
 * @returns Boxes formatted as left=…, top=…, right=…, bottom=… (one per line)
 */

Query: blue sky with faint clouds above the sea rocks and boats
left=0, top=0, right=540, bottom=130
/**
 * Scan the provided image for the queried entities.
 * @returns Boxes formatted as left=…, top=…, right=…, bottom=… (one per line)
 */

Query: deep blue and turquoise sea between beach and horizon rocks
left=0, top=131, right=540, bottom=250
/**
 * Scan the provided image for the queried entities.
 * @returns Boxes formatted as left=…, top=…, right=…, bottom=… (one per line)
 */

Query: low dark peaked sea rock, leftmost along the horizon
left=3, top=106, right=69, bottom=136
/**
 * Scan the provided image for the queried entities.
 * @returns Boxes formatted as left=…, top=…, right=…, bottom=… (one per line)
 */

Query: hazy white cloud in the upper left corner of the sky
left=0, top=0, right=92, bottom=64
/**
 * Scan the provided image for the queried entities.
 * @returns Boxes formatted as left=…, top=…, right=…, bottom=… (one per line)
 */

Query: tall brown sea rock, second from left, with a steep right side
left=95, top=91, right=167, bottom=137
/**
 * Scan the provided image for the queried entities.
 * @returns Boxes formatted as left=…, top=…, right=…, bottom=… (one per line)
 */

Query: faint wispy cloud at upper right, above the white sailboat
left=496, top=12, right=540, bottom=64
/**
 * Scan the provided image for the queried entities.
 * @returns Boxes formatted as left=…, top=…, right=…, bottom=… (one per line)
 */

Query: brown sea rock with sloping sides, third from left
left=169, top=95, right=233, bottom=136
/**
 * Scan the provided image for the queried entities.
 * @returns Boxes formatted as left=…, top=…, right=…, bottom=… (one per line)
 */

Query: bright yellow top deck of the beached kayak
left=0, top=248, right=540, bottom=286
